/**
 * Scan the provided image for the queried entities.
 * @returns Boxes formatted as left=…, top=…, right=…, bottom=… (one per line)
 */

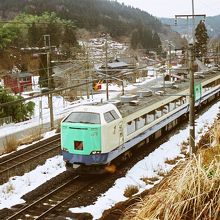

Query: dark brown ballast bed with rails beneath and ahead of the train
left=0, top=100, right=218, bottom=219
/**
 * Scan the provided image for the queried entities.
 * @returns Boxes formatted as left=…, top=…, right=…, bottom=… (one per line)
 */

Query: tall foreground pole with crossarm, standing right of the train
left=175, top=0, right=206, bottom=155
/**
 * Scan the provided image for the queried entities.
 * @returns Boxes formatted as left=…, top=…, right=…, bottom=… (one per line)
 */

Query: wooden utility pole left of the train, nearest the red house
left=44, top=35, right=54, bottom=130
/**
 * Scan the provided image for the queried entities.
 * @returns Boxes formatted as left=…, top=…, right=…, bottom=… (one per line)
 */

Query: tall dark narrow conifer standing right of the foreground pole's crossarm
left=195, top=20, right=209, bottom=60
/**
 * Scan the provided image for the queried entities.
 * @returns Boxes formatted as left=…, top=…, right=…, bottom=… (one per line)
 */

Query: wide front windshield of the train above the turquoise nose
left=63, top=112, right=101, bottom=124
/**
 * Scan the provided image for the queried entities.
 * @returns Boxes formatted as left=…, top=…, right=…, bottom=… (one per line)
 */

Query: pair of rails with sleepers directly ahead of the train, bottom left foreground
left=6, top=175, right=97, bottom=220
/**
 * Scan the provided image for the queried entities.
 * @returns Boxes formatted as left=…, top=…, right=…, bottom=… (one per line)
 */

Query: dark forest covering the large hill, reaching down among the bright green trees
left=0, top=0, right=182, bottom=49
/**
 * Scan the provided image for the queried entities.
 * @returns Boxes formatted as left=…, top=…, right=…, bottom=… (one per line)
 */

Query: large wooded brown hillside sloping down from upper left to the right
left=0, top=0, right=184, bottom=45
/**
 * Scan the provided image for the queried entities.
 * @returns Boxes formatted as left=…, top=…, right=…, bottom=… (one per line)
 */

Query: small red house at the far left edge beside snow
left=3, top=71, right=32, bottom=93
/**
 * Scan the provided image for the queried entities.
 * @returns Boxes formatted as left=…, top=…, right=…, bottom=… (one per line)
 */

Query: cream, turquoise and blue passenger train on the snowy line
left=61, top=71, right=220, bottom=174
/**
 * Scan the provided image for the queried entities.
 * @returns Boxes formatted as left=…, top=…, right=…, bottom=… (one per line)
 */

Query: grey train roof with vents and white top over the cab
left=68, top=71, right=220, bottom=118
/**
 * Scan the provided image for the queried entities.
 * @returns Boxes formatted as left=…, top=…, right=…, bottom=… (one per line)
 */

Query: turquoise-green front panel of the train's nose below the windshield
left=61, top=122, right=101, bottom=155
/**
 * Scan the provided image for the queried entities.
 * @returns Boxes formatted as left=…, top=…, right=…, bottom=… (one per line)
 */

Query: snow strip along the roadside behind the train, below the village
left=0, top=77, right=155, bottom=138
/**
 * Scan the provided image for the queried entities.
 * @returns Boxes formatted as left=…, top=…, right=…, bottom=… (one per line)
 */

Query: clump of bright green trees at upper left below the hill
left=0, top=12, right=77, bottom=50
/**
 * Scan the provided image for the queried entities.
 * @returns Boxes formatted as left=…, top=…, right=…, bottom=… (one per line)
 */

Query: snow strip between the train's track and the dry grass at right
left=70, top=102, right=220, bottom=219
